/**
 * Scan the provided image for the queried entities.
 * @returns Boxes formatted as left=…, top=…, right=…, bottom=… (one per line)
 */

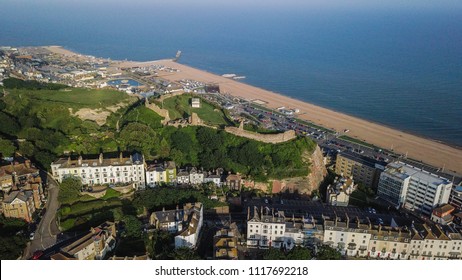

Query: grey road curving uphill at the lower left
left=24, top=174, right=60, bottom=259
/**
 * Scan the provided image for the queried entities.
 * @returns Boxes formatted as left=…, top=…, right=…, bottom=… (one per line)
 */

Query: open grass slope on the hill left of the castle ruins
left=7, top=88, right=135, bottom=109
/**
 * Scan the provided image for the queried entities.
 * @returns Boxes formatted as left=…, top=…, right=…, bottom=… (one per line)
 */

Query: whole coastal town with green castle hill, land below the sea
left=0, top=46, right=462, bottom=260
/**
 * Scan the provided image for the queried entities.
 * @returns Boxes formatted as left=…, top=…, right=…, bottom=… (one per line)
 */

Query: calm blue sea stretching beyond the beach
left=0, top=0, right=462, bottom=146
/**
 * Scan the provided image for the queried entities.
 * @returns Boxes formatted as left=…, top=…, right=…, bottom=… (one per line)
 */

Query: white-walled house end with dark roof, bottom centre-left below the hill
left=175, top=202, right=204, bottom=248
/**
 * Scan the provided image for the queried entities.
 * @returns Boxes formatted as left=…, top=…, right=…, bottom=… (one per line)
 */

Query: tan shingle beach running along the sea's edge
left=45, top=46, right=462, bottom=174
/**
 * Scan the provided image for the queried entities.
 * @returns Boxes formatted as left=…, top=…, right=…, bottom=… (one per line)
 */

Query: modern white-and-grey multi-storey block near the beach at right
left=377, top=162, right=452, bottom=216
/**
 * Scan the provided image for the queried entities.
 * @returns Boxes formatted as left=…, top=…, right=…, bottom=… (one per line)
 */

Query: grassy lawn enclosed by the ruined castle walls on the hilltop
left=163, top=94, right=228, bottom=125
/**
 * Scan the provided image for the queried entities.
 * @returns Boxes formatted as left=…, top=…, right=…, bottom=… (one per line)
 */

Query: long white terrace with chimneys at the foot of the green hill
left=51, top=152, right=146, bottom=188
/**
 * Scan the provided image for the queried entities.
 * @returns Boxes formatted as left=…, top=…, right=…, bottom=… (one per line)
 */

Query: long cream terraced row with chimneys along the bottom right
left=247, top=213, right=462, bottom=260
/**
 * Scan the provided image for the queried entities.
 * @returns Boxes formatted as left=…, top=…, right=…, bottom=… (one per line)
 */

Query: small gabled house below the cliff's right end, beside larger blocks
left=326, top=177, right=356, bottom=206
